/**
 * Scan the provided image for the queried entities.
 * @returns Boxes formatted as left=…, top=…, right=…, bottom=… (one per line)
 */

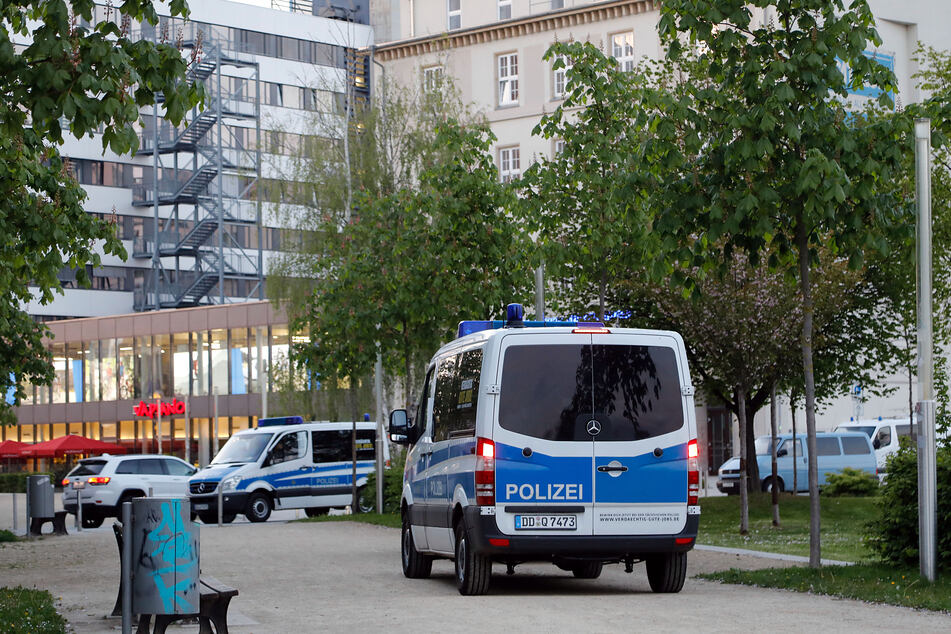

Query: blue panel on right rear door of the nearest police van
left=595, top=443, right=687, bottom=504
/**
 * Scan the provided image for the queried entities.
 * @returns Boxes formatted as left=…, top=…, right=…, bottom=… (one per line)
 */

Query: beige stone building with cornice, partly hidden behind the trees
left=371, top=0, right=951, bottom=471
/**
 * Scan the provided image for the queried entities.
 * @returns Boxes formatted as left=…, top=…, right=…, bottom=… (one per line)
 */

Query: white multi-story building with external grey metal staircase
left=27, top=0, right=372, bottom=320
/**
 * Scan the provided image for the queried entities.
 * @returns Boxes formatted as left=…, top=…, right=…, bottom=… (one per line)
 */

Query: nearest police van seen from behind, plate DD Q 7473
left=389, top=304, right=700, bottom=595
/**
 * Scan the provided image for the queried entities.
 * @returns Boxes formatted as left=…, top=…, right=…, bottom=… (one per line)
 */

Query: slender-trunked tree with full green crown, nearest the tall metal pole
left=651, top=0, right=936, bottom=567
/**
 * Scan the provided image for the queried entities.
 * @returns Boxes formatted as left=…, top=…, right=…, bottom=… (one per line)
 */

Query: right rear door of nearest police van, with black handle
left=589, top=333, right=690, bottom=535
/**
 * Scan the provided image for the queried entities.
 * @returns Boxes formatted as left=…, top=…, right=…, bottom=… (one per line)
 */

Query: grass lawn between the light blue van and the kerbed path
left=697, top=493, right=876, bottom=561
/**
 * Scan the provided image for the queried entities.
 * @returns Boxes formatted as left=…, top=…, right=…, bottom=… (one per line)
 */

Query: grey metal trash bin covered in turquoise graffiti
left=131, top=498, right=199, bottom=614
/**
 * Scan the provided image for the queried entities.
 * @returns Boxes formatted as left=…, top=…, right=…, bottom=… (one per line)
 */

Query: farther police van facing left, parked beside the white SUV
left=188, top=416, right=389, bottom=523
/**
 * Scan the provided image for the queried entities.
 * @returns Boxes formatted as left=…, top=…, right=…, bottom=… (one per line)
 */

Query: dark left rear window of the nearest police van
left=499, top=345, right=593, bottom=440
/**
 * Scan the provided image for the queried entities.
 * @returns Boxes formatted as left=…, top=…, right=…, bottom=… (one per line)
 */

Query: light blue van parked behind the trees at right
left=717, top=432, right=877, bottom=494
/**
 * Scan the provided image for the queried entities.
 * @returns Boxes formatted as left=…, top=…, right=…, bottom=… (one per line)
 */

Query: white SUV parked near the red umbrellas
left=62, top=454, right=197, bottom=528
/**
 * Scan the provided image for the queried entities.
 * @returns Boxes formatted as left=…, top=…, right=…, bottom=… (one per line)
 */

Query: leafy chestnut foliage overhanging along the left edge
left=0, top=0, right=202, bottom=420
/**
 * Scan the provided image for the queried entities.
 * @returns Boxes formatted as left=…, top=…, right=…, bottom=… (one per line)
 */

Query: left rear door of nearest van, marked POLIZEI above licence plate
left=492, top=331, right=594, bottom=535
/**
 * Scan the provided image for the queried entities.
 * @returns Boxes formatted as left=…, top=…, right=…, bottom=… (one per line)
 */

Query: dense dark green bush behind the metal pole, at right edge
left=865, top=438, right=951, bottom=571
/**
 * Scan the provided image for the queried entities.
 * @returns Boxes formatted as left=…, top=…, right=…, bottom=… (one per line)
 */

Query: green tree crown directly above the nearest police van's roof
left=524, top=42, right=652, bottom=321
